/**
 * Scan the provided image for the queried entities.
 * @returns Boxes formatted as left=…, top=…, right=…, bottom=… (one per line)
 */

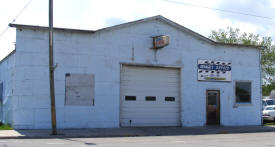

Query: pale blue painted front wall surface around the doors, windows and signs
left=1, top=16, right=261, bottom=129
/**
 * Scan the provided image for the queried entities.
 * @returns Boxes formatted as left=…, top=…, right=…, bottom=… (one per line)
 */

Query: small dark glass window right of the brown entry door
left=235, top=81, right=251, bottom=103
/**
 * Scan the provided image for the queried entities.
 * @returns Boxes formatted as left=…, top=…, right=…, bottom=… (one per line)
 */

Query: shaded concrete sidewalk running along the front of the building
left=0, top=126, right=275, bottom=139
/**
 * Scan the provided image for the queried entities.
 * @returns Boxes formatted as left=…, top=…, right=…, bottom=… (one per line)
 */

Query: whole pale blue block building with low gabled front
left=0, top=16, right=261, bottom=129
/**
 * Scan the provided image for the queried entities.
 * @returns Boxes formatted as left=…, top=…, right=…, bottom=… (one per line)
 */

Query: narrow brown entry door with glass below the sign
left=206, top=90, right=220, bottom=125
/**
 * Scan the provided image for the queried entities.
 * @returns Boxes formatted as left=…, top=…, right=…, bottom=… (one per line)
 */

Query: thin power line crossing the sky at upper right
left=162, top=0, right=275, bottom=21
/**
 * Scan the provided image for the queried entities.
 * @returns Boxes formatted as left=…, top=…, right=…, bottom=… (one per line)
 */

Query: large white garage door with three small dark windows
left=120, top=66, right=180, bottom=127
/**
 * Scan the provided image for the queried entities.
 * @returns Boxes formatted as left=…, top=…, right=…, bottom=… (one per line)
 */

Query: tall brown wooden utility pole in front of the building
left=49, top=0, right=57, bottom=135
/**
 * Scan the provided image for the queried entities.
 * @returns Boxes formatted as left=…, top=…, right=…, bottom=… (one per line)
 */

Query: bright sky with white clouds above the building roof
left=0, top=0, right=275, bottom=59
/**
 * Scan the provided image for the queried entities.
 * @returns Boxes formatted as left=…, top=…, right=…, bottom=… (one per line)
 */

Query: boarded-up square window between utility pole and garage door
left=65, top=73, right=95, bottom=106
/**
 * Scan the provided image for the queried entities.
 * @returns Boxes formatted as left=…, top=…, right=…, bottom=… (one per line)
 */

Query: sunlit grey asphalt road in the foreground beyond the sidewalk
left=0, top=132, right=275, bottom=147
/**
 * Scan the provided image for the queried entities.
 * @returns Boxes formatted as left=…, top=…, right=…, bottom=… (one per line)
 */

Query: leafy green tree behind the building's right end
left=209, top=27, right=275, bottom=86
